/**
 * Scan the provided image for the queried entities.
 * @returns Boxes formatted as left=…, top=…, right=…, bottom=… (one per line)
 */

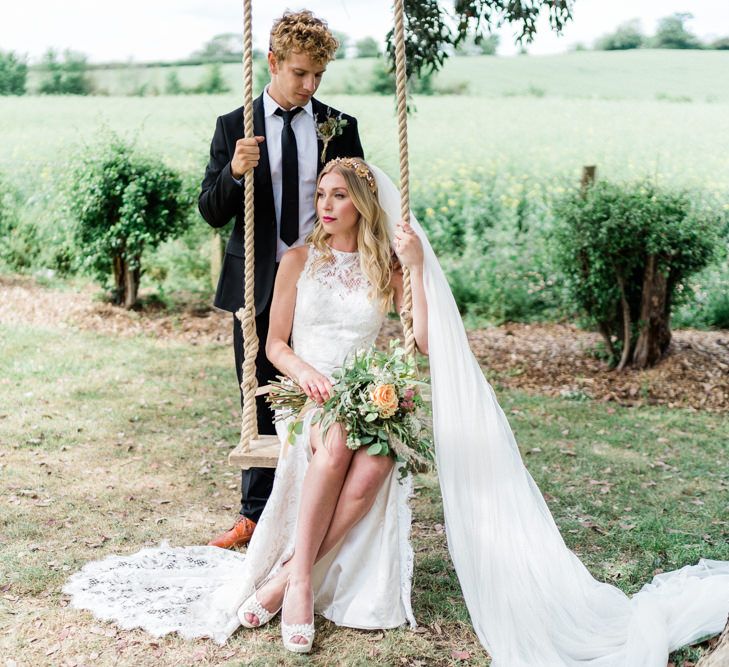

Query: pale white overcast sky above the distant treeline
left=0, top=0, right=729, bottom=62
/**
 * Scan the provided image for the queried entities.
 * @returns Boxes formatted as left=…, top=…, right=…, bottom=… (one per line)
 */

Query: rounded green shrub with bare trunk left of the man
left=71, top=137, right=193, bottom=308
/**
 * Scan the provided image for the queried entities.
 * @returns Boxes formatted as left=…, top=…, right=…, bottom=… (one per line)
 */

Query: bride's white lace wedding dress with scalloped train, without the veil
left=64, top=246, right=415, bottom=644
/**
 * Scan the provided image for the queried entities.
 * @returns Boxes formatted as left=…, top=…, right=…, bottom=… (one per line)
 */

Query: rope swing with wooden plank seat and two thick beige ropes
left=228, top=0, right=415, bottom=470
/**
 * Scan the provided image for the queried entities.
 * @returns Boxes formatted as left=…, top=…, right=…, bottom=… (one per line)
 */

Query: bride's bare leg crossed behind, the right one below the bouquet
left=316, top=448, right=395, bottom=561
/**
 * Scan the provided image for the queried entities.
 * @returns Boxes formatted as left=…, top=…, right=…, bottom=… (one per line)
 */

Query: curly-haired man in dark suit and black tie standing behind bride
left=198, top=11, right=364, bottom=549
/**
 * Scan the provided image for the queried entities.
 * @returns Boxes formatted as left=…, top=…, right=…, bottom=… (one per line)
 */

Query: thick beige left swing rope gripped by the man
left=235, top=0, right=258, bottom=452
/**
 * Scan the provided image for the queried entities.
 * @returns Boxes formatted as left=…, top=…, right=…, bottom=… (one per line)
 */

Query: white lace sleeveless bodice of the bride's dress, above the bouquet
left=291, top=245, right=385, bottom=375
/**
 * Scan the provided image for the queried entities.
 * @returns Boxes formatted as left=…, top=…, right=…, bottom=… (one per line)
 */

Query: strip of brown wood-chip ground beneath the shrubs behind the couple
left=5, top=276, right=729, bottom=411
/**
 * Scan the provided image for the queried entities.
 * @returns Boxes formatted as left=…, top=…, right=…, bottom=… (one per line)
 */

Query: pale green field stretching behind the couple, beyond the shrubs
left=8, top=51, right=729, bottom=191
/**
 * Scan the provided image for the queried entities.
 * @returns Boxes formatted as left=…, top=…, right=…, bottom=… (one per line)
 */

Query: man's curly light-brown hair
left=268, top=10, right=339, bottom=63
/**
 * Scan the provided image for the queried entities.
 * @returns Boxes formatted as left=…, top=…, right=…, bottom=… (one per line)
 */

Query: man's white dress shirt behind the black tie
left=263, top=88, right=319, bottom=262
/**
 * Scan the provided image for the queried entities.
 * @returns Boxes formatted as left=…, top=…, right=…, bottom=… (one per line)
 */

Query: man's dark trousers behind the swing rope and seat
left=233, top=290, right=279, bottom=523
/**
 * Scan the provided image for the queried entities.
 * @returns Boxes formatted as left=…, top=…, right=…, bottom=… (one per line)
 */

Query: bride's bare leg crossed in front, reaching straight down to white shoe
left=283, top=424, right=354, bottom=644
